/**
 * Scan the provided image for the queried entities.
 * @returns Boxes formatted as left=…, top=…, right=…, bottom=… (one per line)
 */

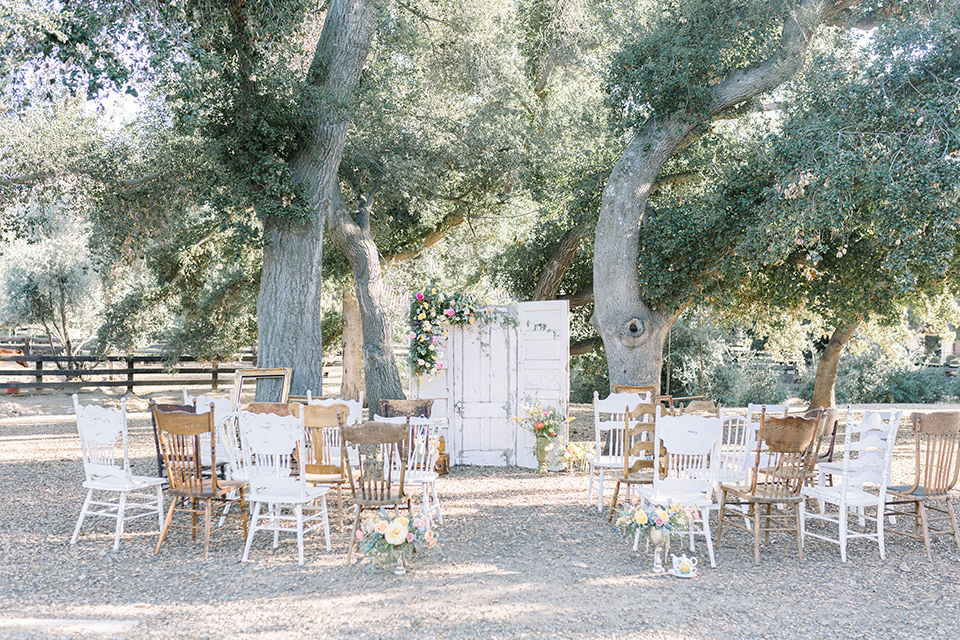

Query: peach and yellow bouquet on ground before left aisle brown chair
left=356, top=509, right=439, bottom=574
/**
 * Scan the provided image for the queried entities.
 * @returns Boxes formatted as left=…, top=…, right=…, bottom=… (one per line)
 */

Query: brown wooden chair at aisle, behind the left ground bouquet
left=340, top=422, right=411, bottom=565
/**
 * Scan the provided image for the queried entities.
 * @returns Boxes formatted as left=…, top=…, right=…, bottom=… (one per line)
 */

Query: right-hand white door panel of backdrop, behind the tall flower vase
left=517, top=300, right=570, bottom=467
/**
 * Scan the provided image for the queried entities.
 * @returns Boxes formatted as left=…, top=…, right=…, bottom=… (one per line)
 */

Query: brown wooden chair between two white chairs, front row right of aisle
left=717, top=410, right=821, bottom=564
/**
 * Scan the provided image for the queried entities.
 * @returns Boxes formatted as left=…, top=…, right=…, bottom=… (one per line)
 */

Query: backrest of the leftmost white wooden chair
left=73, top=394, right=131, bottom=481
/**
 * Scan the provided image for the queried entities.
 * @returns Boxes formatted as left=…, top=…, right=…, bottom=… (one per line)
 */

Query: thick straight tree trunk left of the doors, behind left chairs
left=257, top=0, right=375, bottom=395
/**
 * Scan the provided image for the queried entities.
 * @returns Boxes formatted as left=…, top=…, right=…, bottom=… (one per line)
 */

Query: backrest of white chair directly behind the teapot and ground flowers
left=653, top=407, right=723, bottom=496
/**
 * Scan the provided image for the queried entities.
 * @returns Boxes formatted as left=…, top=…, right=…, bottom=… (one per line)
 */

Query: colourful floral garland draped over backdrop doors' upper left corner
left=408, top=287, right=496, bottom=376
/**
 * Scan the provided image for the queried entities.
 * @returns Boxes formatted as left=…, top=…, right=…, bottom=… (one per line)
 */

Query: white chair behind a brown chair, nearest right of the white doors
left=587, top=391, right=650, bottom=513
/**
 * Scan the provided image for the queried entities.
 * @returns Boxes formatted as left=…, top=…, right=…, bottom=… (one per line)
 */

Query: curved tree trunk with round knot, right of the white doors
left=591, top=0, right=856, bottom=396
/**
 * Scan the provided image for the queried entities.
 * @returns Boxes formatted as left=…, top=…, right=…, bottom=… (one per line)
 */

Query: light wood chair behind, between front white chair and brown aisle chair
left=302, top=404, right=350, bottom=531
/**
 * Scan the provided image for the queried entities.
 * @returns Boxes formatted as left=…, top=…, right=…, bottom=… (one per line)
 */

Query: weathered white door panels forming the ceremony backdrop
left=410, top=300, right=570, bottom=468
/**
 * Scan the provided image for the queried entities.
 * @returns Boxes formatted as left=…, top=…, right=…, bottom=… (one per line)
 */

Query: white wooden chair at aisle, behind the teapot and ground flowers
left=633, top=407, right=723, bottom=567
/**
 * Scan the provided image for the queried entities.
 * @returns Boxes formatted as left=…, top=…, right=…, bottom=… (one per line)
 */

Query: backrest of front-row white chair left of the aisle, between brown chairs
left=239, top=411, right=306, bottom=502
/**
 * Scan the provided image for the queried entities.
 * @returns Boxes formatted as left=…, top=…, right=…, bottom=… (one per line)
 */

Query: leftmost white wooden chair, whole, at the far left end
left=70, top=394, right=164, bottom=551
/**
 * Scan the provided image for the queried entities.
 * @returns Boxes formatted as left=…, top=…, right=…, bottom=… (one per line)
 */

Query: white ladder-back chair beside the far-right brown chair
left=801, top=408, right=900, bottom=562
